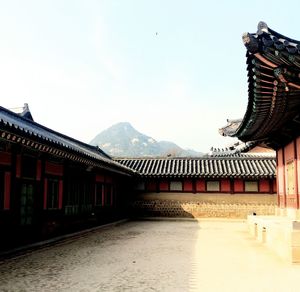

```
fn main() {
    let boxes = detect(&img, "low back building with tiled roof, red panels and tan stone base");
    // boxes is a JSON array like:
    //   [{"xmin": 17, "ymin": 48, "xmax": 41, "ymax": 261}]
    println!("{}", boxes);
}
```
[{"xmin": 117, "ymin": 152, "xmax": 276, "ymax": 218}]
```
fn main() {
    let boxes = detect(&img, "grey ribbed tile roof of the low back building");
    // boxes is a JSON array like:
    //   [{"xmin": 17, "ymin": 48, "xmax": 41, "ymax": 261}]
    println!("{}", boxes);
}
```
[{"xmin": 117, "ymin": 156, "xmax": 276, "ymax": 178}]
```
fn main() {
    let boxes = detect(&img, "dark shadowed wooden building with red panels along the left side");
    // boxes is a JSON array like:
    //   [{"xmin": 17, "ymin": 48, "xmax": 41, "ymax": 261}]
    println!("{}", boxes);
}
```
[{"xmin": 0, "ymin": 106, "xmax": 134, "ymax": 248}]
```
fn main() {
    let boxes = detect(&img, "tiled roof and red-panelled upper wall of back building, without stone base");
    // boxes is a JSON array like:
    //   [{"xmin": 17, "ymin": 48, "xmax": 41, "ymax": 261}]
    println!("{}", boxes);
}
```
[{"xmin": 117, "ymin": 153, "xmax": 276, "ymax": 194}]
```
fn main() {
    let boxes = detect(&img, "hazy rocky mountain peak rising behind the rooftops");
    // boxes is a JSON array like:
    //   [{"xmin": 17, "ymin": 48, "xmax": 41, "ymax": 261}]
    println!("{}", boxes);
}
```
[{"xmin": 90, "ymin": 122, "xmax": 202, "ymax": 157}]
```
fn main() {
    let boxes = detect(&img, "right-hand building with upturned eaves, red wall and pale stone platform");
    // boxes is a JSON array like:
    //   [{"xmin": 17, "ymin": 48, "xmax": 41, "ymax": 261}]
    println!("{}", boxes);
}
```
[{"xmin": 220, "ymin": 22, "xmax": 300, "ymax": 262}]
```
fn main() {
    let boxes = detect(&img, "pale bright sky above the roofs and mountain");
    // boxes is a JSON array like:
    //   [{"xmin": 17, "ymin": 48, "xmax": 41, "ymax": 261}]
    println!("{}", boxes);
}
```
[{"xmin": 0, "ymin": 0, "xmax": 300, "ymax": 152}]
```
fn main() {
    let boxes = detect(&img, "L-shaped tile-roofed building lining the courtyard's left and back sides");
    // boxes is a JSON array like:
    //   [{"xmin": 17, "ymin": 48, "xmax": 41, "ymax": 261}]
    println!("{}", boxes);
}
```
[{"xmin": 0, "ymin": 101, "xmax": 276, "ymax": 248}]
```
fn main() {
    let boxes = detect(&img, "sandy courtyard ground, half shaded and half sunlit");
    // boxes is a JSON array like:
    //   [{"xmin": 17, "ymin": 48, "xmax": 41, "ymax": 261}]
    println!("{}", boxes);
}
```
[{"xmin": 0, "ymin": 220, "xmax": 300, "ymax": 292}]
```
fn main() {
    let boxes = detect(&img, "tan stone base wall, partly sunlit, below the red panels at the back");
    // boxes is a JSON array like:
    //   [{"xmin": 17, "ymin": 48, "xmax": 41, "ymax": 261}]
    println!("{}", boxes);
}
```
[{"xmin": 131, "ymin": 193, "xmax": 276, "ymax": 219}]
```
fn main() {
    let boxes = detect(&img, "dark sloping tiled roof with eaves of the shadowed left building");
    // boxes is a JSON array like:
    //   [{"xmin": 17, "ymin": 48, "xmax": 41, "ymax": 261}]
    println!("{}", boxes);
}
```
[{"xmin": 0, "ymin": 107, "xmax": 132, "ymax": 173}]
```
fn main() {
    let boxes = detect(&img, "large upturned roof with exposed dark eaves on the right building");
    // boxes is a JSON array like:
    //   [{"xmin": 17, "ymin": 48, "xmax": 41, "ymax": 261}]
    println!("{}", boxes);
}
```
[{"xmin": 220, "ymin": 22, "xmax": 300, "ymax": 149}]
